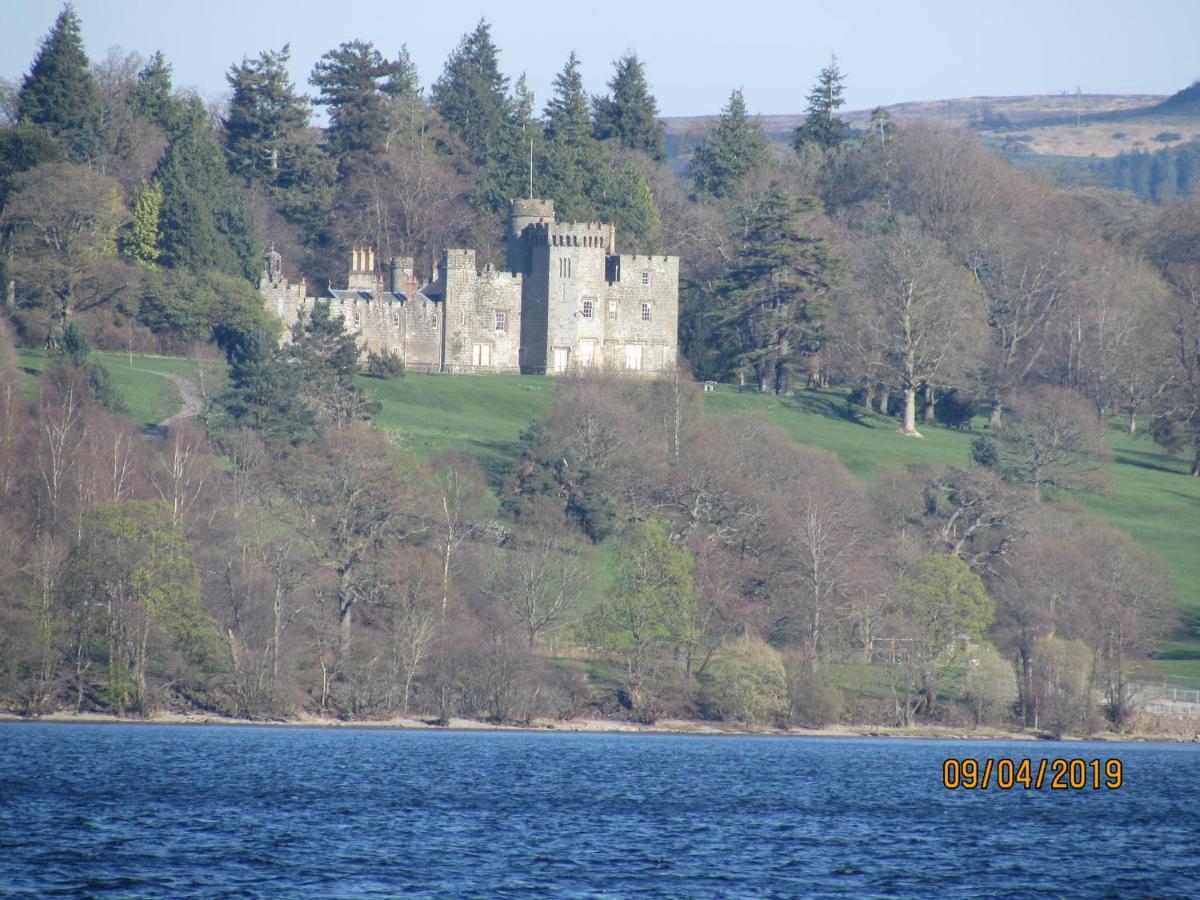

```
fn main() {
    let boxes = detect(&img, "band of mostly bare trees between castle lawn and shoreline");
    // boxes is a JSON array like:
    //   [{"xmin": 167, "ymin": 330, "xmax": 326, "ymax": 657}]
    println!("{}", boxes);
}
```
[{"xmin": 0, "ymin": 316, "xmax": 1174, "ymax": 731}]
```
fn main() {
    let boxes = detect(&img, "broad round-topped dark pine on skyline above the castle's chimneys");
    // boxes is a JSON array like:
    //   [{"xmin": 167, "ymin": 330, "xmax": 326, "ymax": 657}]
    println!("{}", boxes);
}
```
[{"xmin": 308, "ymin": 41, "xmax": 400, "ymax": 157}]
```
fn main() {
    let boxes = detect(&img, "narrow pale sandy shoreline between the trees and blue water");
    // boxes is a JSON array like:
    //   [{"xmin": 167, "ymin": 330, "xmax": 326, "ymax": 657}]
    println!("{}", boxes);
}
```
[{"xmin": 0, "ymin": 712, "xmax": 1200, "ymax": 744}]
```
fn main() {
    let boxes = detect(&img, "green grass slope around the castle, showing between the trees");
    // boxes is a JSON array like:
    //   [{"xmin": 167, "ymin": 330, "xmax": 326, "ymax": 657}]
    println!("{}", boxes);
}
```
[{"xmin": 20, "ymin": 350, "xmax": 1200, "ymax": 683}]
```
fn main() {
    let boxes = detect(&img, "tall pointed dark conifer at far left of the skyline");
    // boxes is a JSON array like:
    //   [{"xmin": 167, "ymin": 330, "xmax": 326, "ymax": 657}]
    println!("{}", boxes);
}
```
[{"xmin": 17, "ymin": 4, "xmax": 102, "ymax": 162}]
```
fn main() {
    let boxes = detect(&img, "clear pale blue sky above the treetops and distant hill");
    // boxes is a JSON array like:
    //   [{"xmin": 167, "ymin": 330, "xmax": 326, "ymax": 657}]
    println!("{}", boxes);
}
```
[{"xmin": 0, "ymin": 0, "xmax": 1200, "ymax": 115}]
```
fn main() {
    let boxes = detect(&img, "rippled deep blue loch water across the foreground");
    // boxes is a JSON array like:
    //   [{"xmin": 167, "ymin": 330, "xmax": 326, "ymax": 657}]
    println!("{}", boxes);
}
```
[{"xmin": 0, "ymin": 724, "xmax": 1200, "ymax": 898}]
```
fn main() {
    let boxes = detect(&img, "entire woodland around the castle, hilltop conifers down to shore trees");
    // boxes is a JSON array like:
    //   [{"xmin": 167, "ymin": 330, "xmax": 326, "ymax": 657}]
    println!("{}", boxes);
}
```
[{"xmin": 0, "ymin": 7, "xmax": 1200, "ymax": 730}]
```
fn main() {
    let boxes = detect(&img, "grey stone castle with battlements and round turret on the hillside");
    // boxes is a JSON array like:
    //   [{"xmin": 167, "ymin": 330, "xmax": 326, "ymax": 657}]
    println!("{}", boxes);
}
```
[{"xmin": 259, "ymin": 199, "xmax": 679, "ymax": 374}]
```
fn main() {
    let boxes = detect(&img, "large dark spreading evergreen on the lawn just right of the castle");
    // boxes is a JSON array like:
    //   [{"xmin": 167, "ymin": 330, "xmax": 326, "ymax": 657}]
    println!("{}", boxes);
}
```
[{"xmin": 715, "ymin": 191, "xmax": 838, "ymax": 394}]
